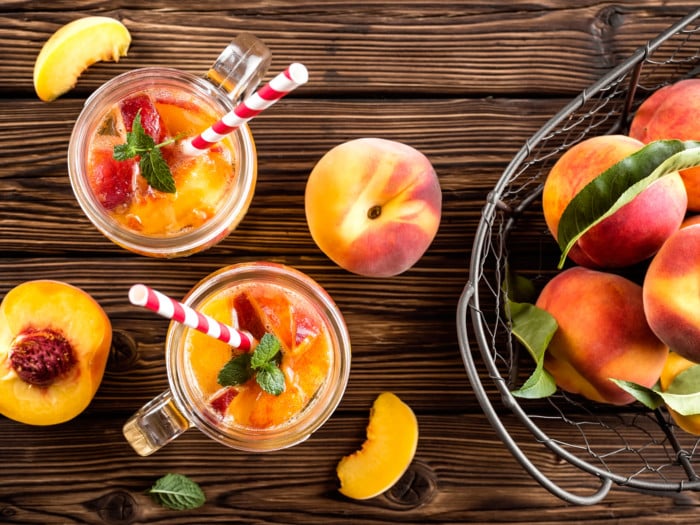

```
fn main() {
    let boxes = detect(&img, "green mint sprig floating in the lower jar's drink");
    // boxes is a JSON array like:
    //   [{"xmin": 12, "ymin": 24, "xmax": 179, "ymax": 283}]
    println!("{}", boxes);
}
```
[{"xmin": 217, "ymin": 333, "xmax": 285, "ymax": 396}]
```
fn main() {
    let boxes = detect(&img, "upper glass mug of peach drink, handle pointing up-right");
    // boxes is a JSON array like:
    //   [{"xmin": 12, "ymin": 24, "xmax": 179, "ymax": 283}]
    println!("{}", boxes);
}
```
[{"xmin": 68, "ymin": 34, "xmax": 270, "ymax": 257}]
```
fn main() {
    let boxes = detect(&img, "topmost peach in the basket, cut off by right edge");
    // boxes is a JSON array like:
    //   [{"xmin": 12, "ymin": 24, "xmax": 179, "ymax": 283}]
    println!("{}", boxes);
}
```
[{"xmin": 629, "ymin": 78, "xmax": 700, "ymax": 211}]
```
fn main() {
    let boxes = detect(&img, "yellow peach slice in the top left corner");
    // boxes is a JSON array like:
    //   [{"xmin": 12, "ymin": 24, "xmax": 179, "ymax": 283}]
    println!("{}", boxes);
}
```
[{"xmin": 34, "ymin": 16, "xmax": 131, "ymax": 102}]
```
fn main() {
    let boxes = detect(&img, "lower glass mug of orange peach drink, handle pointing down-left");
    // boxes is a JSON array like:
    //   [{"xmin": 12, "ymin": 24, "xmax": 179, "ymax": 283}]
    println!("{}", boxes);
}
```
[{"xmin": 124, "ymin": 262, "xmax": 351, "ymax": 455}]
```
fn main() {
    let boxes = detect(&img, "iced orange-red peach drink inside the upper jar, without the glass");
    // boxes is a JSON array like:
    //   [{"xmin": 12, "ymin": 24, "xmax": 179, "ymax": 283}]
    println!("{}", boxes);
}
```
[{"xmin": 87, "ymin": 87, "xmax": 236, "ymax": 237}]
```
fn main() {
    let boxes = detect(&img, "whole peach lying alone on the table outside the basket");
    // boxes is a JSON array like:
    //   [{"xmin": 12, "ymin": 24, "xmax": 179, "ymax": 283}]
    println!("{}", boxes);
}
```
[{"xmin": 305, "ymin": 138, "xmax": 442, "ymax": 277}]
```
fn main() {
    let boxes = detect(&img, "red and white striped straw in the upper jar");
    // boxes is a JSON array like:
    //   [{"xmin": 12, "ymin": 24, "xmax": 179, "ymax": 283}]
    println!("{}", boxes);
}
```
[{"xmin": 183, "ymin": 62, "xmax": 309, "ymax": 155}]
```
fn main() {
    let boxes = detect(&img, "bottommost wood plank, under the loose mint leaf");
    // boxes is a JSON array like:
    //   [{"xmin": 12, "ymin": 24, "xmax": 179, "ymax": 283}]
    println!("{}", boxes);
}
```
[{"xmin": 0, "ymin": 413, "xmax": 699, "ymax": 524}]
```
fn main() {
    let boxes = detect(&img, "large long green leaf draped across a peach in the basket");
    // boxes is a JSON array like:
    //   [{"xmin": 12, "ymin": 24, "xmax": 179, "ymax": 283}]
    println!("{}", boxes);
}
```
[{"xmin": 557, "ymin": 140, "xmax": 700, "ymax": 268}]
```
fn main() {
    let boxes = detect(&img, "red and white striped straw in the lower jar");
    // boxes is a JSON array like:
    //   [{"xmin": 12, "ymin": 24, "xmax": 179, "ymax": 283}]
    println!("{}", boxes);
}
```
[{"xmin": 129, "ymin": 284, "xmax": 253, "ymax": 352}]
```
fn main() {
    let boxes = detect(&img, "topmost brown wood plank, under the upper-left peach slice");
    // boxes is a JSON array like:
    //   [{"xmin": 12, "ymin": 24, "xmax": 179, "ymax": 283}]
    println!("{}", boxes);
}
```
[{"xmin": 0, "ymin": 0, "xmax": 697, "ymax": 96}]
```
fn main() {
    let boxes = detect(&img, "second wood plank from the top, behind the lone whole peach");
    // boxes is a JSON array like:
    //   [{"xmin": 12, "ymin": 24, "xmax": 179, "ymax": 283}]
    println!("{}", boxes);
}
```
[{"xmin": 0, "ymin": 99, "xmax": 563, "ymax": 257}]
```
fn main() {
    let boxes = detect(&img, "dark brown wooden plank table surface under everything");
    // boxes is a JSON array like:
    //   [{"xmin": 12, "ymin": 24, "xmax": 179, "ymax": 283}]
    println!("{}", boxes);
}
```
[{"xmin": 0, "ymin": 0, "xmax": 700, "ymax": 524}]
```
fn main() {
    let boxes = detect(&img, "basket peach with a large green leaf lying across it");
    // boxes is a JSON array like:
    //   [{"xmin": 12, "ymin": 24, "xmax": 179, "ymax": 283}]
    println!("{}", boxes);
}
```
[{"xmin": 542, "ymin": 135, "xmax": 687, "ymax": 268}]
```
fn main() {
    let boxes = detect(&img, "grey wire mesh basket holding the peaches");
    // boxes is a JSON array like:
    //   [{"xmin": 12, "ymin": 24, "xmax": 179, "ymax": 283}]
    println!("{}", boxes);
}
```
[{"xmin": 457, "ymin": 9, "xmax": 700, "ymax": 505}]
